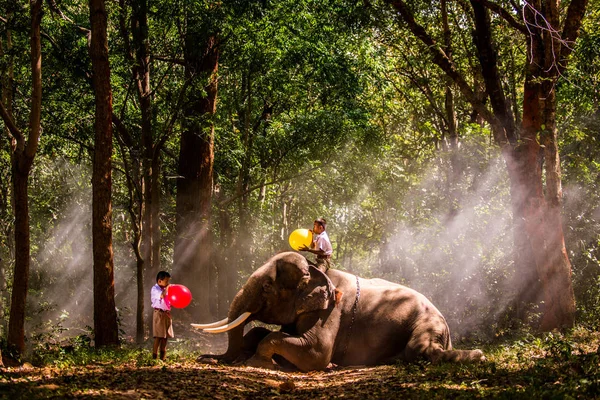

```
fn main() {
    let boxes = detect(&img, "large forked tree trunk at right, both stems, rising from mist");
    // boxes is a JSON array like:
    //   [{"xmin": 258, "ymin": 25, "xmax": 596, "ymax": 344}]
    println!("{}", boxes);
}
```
[{"xmin": 471, "ymin": 0, "xmax": 575, "ymax": 331}]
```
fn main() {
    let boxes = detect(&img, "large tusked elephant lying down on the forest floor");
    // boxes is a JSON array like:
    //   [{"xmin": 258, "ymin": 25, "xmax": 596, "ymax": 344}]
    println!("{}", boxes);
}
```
[{"xmin": 192, "ymin": 252, "xmax": 485, "ymax": 371}]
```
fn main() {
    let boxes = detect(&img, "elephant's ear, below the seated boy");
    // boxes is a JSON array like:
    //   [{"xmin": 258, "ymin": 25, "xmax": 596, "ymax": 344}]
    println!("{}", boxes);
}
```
[{"xmin": 296, "ymin": 266, "xmax": 342, "ymax": 314}]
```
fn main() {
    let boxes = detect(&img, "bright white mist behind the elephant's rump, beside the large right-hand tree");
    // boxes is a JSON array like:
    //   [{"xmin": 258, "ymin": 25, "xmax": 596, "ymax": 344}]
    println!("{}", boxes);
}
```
[{"xmin": 380, "ymin": 159, "xmax": 514, "ymax": 340}]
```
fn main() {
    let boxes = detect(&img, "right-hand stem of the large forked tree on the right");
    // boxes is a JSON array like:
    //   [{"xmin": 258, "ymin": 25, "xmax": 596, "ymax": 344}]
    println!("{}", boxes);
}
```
[{"xmin": 522, "ymin": 0, "xmax": 586, "ymax": 331}]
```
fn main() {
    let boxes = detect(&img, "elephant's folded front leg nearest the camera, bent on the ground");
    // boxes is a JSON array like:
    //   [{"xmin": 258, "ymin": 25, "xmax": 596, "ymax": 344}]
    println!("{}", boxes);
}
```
[{"xmin": 246, "ymin": 332, "xmax": 331, "ymax": 371}]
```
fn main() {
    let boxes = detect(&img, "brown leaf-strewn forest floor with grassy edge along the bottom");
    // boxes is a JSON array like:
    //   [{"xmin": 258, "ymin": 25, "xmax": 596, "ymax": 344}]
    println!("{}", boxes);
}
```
[{"xmin": 0, "ymin": 326, "xmax": 600, "ymax": 399}]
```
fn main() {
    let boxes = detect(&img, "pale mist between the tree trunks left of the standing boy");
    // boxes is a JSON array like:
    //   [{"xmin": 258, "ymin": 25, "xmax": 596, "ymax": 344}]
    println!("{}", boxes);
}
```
[{"xmin": 26, "ymin": 165, "xmax": 137, "ymax": 344}]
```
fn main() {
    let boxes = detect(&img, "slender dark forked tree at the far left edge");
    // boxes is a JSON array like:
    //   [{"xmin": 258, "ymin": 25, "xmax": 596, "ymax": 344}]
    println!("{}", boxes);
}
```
[{"xmin": 0, "ymin": 0, "xmax": 43, "ymax": 353}]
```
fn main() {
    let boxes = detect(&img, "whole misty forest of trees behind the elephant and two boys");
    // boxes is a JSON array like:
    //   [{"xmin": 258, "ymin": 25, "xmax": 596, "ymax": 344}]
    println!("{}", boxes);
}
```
[{"xmin": 0, "ymin": 0, "xmax": 600, "ymax": 366}]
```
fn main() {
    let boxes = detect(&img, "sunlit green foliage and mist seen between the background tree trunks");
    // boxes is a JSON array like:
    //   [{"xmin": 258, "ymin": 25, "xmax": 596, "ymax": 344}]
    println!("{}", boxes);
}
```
[{"xmin": 0, "ymin": 0, "xmax": 600, "ymax": 354}]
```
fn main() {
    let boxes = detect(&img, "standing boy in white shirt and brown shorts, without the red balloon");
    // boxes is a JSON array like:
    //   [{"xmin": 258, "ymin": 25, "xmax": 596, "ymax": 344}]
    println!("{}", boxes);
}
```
[{"xmin": 150, "ymin": 271, "xmax": 173, "ymax": 360}]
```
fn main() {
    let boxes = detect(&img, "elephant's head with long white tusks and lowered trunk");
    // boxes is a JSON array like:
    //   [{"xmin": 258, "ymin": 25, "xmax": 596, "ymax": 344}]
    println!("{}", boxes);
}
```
[{"xmin": 192, "ymin": 252, "xmax": 340, "ymax": 362}]
